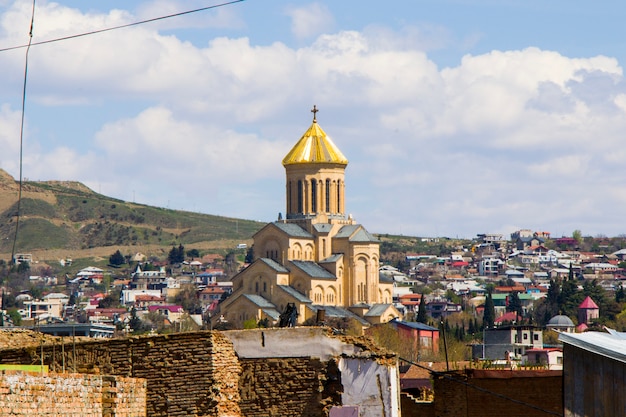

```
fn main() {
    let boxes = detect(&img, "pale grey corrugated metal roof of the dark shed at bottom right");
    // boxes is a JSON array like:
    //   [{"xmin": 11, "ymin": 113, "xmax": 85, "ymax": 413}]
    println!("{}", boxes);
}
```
[{"xmin": 559, "ymin": 330, "xmax": 626, "ymax": 363}]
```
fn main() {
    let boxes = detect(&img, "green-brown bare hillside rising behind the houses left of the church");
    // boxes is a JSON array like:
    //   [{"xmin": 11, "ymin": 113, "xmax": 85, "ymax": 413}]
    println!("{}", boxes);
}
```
[{"xmin": 0, "ymin": 169, "xmax": 263, "ymax": 259}]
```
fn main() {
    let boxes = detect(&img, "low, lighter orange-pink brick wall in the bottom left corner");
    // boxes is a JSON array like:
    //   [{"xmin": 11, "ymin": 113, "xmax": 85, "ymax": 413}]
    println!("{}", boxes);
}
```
[{"xmin": 0, "ymin": 371, "xmax": 146, "ymax": 417}]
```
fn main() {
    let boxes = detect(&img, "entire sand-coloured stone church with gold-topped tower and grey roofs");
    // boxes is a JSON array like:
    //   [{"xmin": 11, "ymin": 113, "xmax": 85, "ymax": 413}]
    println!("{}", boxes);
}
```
[{"xmin": 218, "ymin": 106, "xmax": 401, "ymax": 328}]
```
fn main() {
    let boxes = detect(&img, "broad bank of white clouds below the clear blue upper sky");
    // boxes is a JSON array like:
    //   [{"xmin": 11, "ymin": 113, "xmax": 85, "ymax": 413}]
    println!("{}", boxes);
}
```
[{"xmin": 0, "ymin": 2, "xmax": 626, "ymax": 236}]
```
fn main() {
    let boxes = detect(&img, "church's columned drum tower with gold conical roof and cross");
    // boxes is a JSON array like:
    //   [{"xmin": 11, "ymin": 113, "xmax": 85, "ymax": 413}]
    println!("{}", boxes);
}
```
[{"xmin": 283, "ymin": 106, "xmax": 348, "ymax": 220}]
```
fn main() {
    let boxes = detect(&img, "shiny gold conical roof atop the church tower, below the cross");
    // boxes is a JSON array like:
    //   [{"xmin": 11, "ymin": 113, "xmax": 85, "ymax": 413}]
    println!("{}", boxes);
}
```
[{"xmin": 283, "ymin": 119, "xmax": 348, "ymax": 166}]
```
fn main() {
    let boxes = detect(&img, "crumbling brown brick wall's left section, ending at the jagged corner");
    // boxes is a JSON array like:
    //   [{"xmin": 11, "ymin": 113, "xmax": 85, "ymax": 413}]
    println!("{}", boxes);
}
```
[{"xmin": 0, "ymin": 332, "xmax": 241, "ymax": 417}]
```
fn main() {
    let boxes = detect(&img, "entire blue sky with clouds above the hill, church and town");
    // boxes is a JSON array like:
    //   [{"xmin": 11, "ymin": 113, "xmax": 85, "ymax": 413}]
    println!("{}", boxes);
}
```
[{"xmin": 0, "ymin": 0, "xmax": 626, "ymax": 237}]
